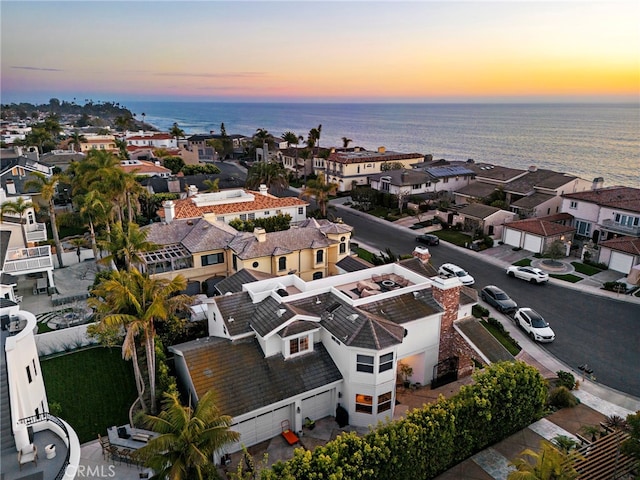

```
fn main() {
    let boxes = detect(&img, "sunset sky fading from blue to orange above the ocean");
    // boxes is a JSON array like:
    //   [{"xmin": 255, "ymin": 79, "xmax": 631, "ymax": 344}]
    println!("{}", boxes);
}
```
[{"xmin": 0, "ymin": 0, "xmax": 640, "ymax": 104}]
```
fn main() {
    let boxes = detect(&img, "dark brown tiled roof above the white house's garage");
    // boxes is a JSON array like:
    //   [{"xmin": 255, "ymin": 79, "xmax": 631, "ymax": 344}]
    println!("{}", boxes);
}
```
[{"xmin": 171, "ymin": 337, "xmax": 342, "ymax": 417}]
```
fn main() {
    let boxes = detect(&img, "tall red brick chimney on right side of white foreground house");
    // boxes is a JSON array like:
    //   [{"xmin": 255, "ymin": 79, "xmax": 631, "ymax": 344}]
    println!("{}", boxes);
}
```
[{"xmin": 431, "ymin": 277, "xmax": 462, "ymax": 361}]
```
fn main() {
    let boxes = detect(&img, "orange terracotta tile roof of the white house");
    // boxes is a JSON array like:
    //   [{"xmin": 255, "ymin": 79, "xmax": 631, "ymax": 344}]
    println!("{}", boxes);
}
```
[{"xmin": 166, "ymin": 190, "xmax": 309, "ymax": 218}]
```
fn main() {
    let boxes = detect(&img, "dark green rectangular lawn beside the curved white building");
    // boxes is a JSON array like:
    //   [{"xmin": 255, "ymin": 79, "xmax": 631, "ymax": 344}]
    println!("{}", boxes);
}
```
[{"xmin": 40, "ymin": 347, "xmax": 136, "ymax": 443}]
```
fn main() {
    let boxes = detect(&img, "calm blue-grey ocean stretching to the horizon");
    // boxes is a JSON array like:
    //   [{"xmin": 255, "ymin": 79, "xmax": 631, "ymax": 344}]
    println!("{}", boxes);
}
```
[{"xmin": 126, "ymin": 102, "xmax": 640, "ymax": 188}]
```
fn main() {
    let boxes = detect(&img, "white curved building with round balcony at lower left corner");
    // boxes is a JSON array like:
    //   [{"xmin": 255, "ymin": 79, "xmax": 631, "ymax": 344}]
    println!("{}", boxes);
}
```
[{"xmin": 0, "ymin": 298, "xmax": 80, "ymax": 480}]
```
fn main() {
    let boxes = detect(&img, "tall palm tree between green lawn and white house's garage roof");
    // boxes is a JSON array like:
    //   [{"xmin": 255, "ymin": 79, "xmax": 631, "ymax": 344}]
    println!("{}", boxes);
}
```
[{"xmin": 88, "ymin": 268, "xmax": 191, "ymax": 412}]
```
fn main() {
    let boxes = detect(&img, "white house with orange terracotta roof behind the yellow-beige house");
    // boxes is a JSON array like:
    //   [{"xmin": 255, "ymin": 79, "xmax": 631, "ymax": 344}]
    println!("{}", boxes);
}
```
[{"xmin": 158, "ymin": 185, "xmax": 309, "ymax": 227}]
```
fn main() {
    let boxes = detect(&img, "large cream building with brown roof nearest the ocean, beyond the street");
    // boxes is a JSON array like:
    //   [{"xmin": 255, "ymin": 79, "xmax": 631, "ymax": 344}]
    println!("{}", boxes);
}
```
[{"xmin": 324, "ymin": 147, "xmax": 424, "ymax": 192}]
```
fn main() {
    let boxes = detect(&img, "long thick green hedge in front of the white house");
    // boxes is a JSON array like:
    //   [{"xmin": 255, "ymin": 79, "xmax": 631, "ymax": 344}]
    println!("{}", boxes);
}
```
[{"xmin": 261, "ymin": 362, "xmax": 547, "ymax": 480}]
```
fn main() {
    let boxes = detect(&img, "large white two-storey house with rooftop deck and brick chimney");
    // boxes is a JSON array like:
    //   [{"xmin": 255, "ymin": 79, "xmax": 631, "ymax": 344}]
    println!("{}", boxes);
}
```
[{"xmin": 170, "ymin": 264, "xmax": 480, "ymax": 452}]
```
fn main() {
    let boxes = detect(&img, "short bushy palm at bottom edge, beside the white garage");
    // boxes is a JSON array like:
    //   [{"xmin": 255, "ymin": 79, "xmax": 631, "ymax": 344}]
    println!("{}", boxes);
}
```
[{"xmin": 136, "ymin": 390, "xmax": 240, "ymax": 480}]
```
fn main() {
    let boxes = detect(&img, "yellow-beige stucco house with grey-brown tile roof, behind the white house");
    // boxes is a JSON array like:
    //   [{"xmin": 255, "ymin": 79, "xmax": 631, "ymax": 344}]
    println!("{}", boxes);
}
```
[{"xmin": 143, "ymin": 218, "xmax": 353, "ymax": 284}]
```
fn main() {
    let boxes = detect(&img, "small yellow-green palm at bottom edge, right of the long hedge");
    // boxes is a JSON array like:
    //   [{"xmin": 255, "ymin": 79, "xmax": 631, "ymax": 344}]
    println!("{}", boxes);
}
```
[{"xmin": 507, "ymin": 440, "xmax": 580, "ymax": 480}]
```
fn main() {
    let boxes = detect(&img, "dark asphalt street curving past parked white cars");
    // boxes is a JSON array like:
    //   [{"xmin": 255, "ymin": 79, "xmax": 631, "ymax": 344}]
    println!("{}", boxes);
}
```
[{"xmin": 332, "ymin": 202, "xmax": 640, "ymax": 397}]
